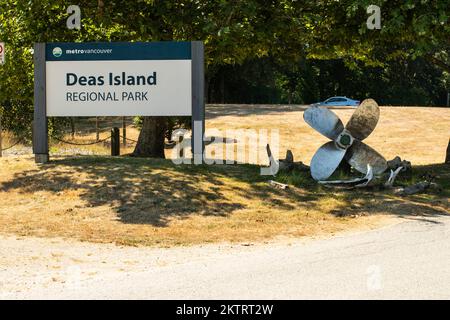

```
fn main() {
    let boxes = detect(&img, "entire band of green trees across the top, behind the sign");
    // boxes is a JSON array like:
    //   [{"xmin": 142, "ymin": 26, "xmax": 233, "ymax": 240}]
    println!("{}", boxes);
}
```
[{"xmin": 0, "ymin": 0, "xmax": 450, "ymax": 139}]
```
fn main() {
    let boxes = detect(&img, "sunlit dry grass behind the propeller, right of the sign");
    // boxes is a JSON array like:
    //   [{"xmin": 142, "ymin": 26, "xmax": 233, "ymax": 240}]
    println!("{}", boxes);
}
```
[{"xmin": 206, "ymin": 106, "xmax": 450, "ymax": 165}]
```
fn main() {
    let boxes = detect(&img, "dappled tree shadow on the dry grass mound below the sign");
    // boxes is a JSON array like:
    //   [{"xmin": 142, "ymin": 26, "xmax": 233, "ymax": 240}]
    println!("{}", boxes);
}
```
[{"xmin": 0, "ymin": 156, "xmax": 320, "ymax": 227}]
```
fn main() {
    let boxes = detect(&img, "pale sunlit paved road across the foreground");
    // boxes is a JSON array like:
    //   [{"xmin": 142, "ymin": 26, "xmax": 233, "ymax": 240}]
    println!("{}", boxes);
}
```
[{"xmin": 0, "ymin": 216, "xmax": 450, "ymax": 299}]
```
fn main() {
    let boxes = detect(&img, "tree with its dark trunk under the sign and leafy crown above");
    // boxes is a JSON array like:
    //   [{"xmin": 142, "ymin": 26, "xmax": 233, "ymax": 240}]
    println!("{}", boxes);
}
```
[{"xmin": 128, "ymin": 0, "xmax": 314, "ymax": 157}]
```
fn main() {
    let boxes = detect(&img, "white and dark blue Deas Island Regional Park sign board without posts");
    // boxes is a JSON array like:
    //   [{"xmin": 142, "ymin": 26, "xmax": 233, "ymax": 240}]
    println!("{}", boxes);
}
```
[{"xmin": 45, "ymin": 42, "xmax": 192, "ymax": 117}]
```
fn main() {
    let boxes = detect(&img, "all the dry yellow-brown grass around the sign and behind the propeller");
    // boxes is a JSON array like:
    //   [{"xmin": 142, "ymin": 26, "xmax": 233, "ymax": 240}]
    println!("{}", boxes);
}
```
[{"xmin": 0, "ymin": 106, "xmax": 450, "ymax": 246}]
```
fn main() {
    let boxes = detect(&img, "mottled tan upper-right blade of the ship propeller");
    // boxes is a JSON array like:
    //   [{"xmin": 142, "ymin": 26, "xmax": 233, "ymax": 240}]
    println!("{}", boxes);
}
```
[{"xmin": 345, "ymin": 99, "xmax": 380, "ymax": 141}]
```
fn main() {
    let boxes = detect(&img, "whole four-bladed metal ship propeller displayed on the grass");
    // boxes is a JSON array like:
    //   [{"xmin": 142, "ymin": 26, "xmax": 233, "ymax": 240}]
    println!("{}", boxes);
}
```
[{"xmin": 303, "ymin": 99, "xmax": 387, "ymax": 181}]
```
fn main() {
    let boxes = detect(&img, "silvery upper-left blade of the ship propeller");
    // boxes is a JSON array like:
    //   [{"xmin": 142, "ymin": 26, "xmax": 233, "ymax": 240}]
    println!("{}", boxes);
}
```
[{"xmin": 303, "ymin": 106, "xmax": 344, "ymax": 140}]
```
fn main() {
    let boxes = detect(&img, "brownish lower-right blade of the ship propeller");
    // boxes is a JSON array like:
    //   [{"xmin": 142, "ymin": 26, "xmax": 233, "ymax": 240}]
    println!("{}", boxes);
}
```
[{"xmin": 345, "ymin": 140, "xmax": 387, "ymax": 175}]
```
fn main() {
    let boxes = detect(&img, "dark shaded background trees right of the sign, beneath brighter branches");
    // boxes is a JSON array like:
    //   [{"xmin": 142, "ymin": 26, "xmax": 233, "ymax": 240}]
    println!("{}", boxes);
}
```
[{"xmin": 208, "ymin": 58, "xmax": 448, "ymax": 106}]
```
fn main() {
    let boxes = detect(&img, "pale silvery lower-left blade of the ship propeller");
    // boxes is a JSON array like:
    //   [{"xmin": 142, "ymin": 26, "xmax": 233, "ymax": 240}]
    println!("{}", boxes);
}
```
[{"xmin": 310, "ymin": 141, "xmax": 346, "ymax": 181}]
